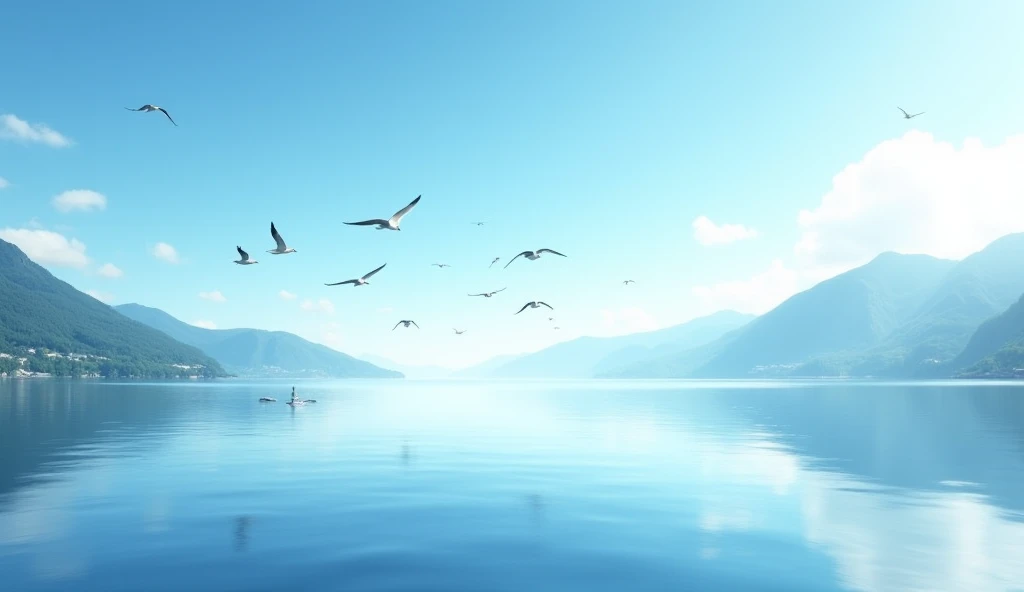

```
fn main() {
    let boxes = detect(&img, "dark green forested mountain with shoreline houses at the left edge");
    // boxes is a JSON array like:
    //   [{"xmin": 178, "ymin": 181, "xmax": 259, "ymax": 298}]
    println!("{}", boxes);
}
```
[{"xmin": 0, "ymin": 241, "xmax": 225, "ymax": 378}]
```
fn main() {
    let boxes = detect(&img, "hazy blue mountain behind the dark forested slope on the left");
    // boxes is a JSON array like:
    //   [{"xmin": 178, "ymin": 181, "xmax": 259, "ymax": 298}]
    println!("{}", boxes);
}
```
[{"xmin": 115, "ymin": 304, "xmax": 402, "ymax": 378}]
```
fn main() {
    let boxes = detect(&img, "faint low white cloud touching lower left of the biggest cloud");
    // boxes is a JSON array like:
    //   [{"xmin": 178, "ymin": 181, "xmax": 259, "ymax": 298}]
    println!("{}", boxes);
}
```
[{"xmin": 692, "ymin": 259, "xmax": 803, "ymax": 314}]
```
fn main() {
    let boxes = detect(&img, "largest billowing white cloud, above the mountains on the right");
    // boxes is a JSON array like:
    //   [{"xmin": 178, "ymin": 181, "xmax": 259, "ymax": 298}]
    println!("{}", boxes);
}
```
[{"xmin": 795, "ymin": 131, "xmax": 1024, "ymax": 269}]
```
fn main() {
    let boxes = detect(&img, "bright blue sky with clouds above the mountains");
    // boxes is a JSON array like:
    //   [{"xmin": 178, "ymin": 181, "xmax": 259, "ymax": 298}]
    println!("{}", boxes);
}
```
[{"xmin": 0, "ymin": 1, "xmax": 1024, "ymax": 367}]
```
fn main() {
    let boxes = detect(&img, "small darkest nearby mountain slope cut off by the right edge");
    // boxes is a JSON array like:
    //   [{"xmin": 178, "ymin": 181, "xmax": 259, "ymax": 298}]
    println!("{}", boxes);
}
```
[{"xmin": 951, "ymin": 296, "xmax": 1024, "ymax": 377}]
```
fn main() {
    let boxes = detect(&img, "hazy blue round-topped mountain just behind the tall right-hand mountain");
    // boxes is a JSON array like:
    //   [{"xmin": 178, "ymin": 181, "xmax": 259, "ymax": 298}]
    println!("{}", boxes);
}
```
[{"xmin": 692, "ymin": 253, "xmax": 956, "ymax": 378}]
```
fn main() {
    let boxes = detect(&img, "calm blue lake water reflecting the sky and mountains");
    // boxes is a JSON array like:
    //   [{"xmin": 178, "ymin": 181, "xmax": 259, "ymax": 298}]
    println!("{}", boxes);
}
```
[{"xmin": 0, "ymin": 380, "xmax": 1024, "ymax": 592}]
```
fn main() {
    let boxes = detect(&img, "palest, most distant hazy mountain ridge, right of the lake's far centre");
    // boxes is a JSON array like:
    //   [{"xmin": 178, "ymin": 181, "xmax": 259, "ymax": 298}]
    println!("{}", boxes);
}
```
[{"xmin": 468, "ymin": 310, "xmax": 753, "ymax": 378}]
